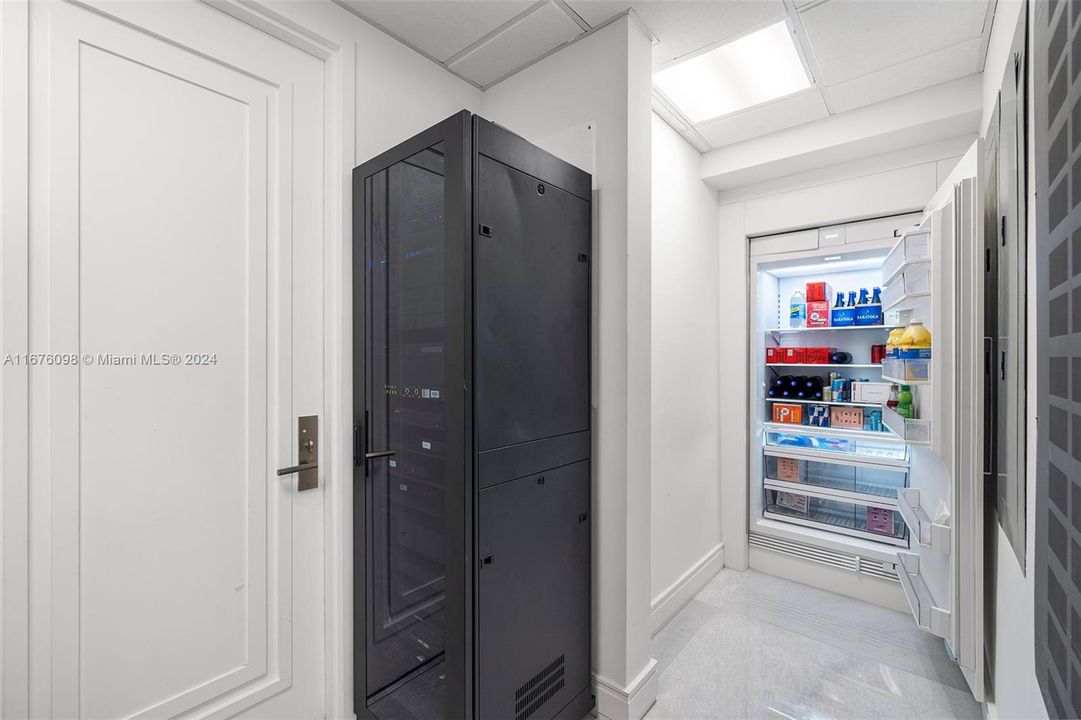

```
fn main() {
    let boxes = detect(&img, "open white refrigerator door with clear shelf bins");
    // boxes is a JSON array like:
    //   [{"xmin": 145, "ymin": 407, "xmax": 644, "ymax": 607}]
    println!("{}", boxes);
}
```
[{"xmin": 897, "ymin": 178, "xmax": 984, "ymax": 701}]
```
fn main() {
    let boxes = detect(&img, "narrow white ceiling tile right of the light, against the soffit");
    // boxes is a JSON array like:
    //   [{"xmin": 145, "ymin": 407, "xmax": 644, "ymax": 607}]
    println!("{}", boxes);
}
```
[{"xmin": 827, "ymin": 38, "xmax": 980, "ymax": 112}]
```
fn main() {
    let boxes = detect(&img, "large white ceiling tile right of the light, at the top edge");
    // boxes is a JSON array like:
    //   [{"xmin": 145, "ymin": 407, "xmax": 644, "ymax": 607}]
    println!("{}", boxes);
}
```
[{"xmin": 800, "ymin": 0, "xmax": 988, "ymax": 85}]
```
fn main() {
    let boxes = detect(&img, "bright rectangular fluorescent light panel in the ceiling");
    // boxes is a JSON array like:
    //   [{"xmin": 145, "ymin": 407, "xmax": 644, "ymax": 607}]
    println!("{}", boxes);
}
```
[{"xmin": 653, "ymin": 22, "xmax": 811, "ymax": 123}]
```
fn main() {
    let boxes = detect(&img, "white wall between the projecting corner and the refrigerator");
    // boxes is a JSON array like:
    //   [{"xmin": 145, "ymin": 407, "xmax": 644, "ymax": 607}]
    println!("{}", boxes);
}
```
[{"xmin": 650, "ymin": 115, "xmax": 726, "ymax": 626}]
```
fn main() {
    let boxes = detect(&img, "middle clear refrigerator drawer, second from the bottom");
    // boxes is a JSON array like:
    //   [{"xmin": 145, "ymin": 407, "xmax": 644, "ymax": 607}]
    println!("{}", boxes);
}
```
[{"xmin": 765, "ymin": 454, "xmax": 908, "ymax": 503}]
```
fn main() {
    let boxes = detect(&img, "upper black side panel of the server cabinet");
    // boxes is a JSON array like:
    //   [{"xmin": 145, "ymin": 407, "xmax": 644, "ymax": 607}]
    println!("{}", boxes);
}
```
[{"xmin": 473, "ymin": 156, "xmax": 589, "ymax": 452}]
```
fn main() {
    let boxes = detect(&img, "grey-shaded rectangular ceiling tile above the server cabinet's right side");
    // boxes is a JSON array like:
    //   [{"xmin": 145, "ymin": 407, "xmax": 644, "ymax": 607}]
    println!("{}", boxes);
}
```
[{"xmin": 450, "ymin": 3, "xmax": 583, "ymax": 88}]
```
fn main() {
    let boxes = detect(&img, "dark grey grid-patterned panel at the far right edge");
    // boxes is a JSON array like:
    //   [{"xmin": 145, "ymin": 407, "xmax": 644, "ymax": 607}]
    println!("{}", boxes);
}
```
[{"xmin": 1033, "ymin": 2, "xmax": 1081, "ymax": 718}]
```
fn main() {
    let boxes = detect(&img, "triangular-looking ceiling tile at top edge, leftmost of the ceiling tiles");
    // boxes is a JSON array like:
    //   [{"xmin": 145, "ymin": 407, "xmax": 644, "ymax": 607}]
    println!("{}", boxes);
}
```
[{"xmin": 341, "ymin": 0, "xmax": 535, "ymax": 61}]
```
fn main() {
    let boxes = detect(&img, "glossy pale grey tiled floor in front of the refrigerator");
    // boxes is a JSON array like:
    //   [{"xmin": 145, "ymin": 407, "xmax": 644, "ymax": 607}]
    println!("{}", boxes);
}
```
[{"xmin": 646, "ymin": 569, "xmax": 982, "ymax": 720}]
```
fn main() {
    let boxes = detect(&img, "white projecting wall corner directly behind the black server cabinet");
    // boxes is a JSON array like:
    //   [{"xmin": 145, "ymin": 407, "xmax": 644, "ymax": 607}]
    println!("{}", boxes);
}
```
[{"xmin": 482, "ymin": 16, "xmax": 656, "ymax": 720}]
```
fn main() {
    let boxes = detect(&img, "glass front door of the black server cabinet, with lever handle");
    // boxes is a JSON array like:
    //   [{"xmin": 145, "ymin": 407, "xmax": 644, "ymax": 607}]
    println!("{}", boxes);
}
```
[{"xmin": 352, "ymin": 112, "xmax": 473, "ymax": 718}]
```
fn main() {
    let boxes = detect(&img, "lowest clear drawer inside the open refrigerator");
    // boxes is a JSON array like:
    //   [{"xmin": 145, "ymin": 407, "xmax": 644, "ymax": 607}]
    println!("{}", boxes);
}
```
[{"xmin": 763, "ymin": 485, "xmax": 908, "ymax": 547}]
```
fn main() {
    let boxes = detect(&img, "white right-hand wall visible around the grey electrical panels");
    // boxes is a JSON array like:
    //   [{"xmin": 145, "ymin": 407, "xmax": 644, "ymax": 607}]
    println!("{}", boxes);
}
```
[{"xmin": 980, "ymin": 0, "xmax": 1047, "ymax": 720}]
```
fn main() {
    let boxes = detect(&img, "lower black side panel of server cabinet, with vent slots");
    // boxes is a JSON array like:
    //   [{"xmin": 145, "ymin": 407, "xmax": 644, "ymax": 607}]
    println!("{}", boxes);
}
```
[{"xmin": 477, "ymin": 461, "xmax": 590, "ymax": 720}]
